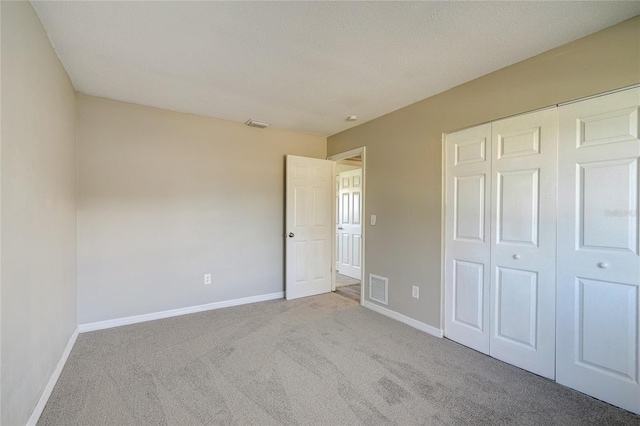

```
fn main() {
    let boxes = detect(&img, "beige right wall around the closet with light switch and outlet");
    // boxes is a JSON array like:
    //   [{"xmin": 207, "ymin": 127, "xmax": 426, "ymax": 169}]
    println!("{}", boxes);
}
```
[{"xmin": 327, "ymin": 17, "xmax": 640, "ymax": 328}]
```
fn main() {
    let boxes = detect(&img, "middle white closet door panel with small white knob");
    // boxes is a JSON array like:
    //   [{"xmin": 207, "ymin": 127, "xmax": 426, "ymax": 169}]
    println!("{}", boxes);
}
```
[{"xmin": 490, "ymin": 108, "xmax": 558, "ymax": 379}]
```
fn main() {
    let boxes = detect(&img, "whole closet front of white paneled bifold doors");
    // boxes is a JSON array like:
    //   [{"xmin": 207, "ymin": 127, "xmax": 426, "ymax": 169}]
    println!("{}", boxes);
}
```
[{"xmin": 444, "ymin": 88, "xmax": 640, "ymax": 413}]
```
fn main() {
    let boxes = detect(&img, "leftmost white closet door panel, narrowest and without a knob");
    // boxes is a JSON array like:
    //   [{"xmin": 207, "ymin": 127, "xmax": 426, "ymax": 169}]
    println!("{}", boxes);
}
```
[{"xmin": 445, "ymin": 124, "xmax": 491, "ymax": 353}]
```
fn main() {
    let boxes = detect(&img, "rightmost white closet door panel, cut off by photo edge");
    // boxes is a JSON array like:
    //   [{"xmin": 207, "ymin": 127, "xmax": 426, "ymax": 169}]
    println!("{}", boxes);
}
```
[{"xmin": 557, "ymin": 89, "xmax": 640, "ymax": 413}]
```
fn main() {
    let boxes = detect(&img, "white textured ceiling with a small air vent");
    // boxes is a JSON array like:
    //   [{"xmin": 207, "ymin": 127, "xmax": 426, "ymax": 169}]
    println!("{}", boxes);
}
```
[{"xmin": 32, "ymin": 1, "xmax": 640, "ymax": 136}]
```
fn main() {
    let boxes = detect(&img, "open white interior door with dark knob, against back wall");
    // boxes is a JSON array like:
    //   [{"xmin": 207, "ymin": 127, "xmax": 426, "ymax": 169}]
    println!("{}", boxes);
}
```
[{"xmin": 285, "ymin": 155, "xmax": 335, "ymax": 300}]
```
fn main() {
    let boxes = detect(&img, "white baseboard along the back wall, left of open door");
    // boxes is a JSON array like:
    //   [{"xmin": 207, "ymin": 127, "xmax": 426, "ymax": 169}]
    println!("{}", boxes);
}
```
[{"xmin": 78, "ymin": 291, "xmax": 284, "ymax": 333}]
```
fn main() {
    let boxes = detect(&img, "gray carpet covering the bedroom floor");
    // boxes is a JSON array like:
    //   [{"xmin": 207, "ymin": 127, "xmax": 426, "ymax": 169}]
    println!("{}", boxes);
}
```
[{"xmin": 39, "ymin": 293, "xmax": 640, "ymax": 425}]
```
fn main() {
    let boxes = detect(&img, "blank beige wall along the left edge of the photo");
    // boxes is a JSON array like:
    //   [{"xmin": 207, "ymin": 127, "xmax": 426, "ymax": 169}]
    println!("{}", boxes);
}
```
[{"xmin": 0, "ymin": 2, "xmax": 77, "ymax": 425}]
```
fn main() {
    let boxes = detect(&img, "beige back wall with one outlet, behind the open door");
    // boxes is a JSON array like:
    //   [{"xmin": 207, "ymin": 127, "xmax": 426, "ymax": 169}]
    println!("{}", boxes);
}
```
[{"xmin": 77, "ymin": 95, "xmax": 326, "ymax": 324}]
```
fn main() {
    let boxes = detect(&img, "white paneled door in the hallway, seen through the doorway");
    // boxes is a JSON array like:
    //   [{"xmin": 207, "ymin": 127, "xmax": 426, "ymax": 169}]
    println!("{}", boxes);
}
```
[{"xmin": 336, "ymin": 169, "xmax": 362, "ymax": 280}]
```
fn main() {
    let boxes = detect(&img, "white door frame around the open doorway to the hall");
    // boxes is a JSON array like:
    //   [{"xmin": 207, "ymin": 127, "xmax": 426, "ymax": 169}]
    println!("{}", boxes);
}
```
[{"xmin": 327, "ymin": 146, "xmax": 367, "ymax": 305}]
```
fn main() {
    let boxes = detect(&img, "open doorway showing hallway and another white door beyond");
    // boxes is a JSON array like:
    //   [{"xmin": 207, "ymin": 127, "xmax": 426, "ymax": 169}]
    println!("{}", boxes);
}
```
[{"xmin": 328, "ymin": 147, "xmax": 365, "ymax": 304}]
